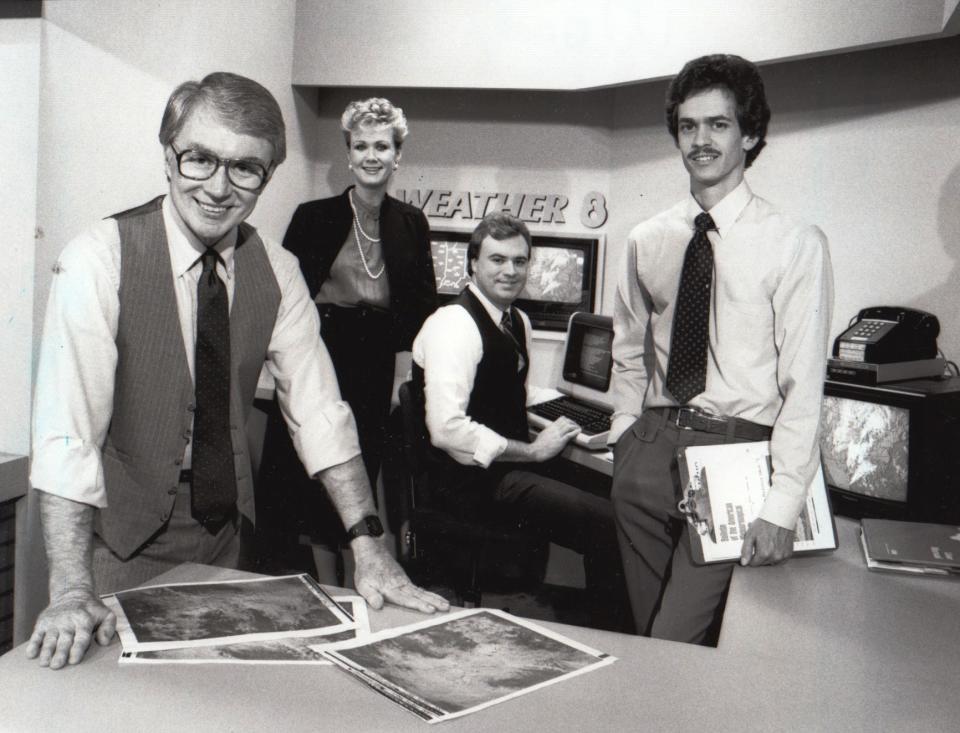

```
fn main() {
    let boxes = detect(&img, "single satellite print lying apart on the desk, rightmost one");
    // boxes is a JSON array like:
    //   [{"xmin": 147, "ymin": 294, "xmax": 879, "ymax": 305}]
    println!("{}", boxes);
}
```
[{"xmin": 316, "ymin": 608, "xmax": 616, "ymax": 723}]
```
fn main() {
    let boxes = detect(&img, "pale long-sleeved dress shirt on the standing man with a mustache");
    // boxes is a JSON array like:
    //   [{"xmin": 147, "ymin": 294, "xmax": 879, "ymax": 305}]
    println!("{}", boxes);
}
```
[{"xmin": 610, "ymin": 181, "xmax": 833, "ymax": 529}]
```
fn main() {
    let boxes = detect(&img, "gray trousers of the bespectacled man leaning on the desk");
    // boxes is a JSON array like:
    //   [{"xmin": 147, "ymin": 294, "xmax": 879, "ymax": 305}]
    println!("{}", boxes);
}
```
[{"xmin": 93, "ymin": 483, "xmax": 249, "ymax": 595}]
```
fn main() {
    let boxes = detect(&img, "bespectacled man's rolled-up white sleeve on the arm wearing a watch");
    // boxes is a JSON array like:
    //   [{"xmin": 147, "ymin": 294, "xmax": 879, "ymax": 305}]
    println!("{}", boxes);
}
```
[{"xmin": 266, "ymin": 247, "xmax": 360, "ymax": 476}]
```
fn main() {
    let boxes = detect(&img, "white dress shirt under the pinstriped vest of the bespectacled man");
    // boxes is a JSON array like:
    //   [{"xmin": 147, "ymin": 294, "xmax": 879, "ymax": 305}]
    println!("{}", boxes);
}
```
[{"xmin": 30, "ymin": 197, "xmax": 360, "ymax": 507}]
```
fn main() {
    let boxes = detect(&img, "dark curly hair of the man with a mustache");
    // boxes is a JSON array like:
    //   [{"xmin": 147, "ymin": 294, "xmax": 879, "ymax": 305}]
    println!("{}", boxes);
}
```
[{"xmin": 666, "ymin": 53, "xmax": 770, "ymax": 168}]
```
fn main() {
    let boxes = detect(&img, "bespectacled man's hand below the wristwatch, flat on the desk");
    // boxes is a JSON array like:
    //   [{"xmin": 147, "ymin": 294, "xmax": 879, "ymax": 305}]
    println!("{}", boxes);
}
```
[{"xmin": 350, "ymin": 537, "xmax": 450, "ymax": 613}]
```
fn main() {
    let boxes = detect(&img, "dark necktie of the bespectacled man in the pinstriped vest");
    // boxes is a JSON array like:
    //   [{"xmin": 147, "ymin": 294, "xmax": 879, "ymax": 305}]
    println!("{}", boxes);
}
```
[{"xmin": 191, "ymin": 248, "xmax": 237, "ymax": 525}]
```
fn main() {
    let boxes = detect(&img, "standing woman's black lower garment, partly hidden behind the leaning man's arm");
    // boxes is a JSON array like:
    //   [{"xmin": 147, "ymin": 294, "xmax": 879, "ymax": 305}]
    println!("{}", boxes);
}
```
[{"xmin": 257, "ymin": 305, "xmax": 395, "ymax": 571}]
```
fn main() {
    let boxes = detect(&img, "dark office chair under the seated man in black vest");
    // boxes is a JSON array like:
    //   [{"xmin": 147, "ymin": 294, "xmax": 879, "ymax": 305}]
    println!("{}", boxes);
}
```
[{"xmin": 391, "ymin": 382, "xmax": 547, "ymax": 606}]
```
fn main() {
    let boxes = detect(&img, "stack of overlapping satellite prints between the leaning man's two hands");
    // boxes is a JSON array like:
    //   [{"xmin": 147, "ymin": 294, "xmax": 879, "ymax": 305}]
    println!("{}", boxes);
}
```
[{"xmin": 104, "ymin": 574, "xmax": 370, "ymax": 664}]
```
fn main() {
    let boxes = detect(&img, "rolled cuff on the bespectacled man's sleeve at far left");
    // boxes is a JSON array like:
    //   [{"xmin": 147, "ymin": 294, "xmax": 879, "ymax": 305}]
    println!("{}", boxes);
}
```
[{"xmin": 30, "ymin": 436, "xmax": 107, "ymax": 509}]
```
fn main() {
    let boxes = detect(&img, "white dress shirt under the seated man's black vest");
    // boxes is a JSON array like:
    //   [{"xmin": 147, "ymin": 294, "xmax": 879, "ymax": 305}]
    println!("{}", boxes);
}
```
[{"xmin": 413, "ymin": 282, "xmax": 554, "ymax": 468}]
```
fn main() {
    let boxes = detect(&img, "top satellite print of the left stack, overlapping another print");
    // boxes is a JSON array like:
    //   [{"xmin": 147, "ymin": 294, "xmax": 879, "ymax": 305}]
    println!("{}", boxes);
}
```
[{"xmin": 103, "ymin": 574, "xmax": 353, "ymax": 652}]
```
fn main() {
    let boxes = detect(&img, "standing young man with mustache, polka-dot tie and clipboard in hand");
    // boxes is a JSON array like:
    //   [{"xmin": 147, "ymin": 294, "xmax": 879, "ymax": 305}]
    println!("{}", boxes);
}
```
[{"xmin": 610, "ymin": 55, "xmax": 833, "ymax": 643}]
